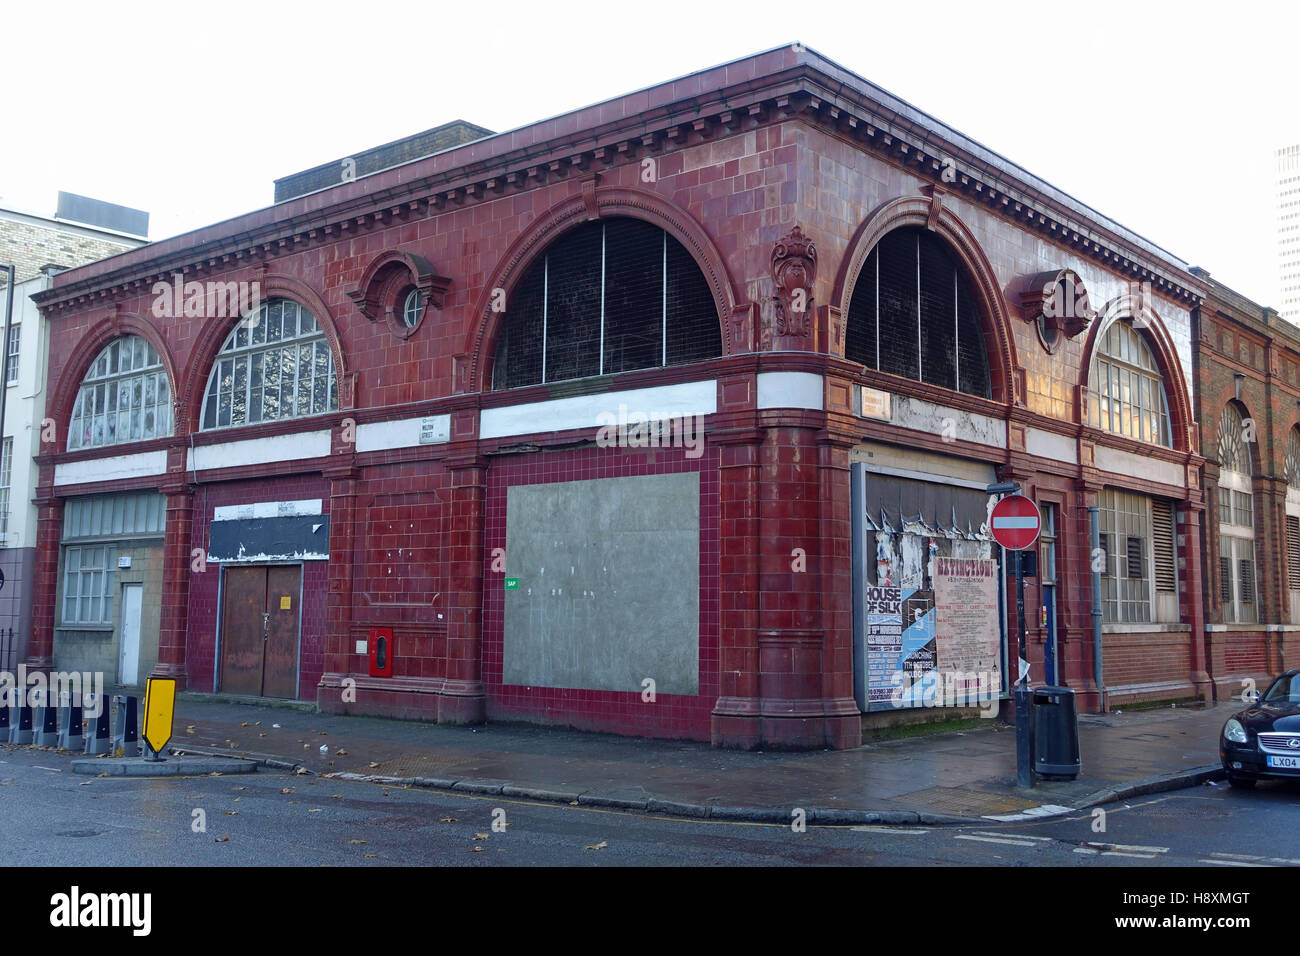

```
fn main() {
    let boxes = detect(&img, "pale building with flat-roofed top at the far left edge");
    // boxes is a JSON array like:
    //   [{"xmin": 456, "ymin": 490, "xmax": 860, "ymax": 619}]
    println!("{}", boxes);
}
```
[{"xmin": 0, "ymin": 193, "xmax": 148, "ymax": 671}]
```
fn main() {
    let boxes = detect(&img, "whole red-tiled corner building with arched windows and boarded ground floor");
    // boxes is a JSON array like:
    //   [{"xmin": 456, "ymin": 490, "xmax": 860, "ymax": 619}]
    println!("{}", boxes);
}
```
[{"xmin": 33, "ymin": 47, "xmax": 1210, "ymax": 747}]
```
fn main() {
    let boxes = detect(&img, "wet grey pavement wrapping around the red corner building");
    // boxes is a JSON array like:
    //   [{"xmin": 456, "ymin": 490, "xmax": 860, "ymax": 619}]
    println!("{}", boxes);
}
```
[{"xmin": 71, "ymin": 693, "xmax": 1242, "ymax": 825}]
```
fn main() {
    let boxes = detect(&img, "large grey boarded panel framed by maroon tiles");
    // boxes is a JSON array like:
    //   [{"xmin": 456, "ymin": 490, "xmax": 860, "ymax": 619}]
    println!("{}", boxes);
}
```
[{"xmin": 491, "ymin": 472, "xmax": 699, "ymax": 695}]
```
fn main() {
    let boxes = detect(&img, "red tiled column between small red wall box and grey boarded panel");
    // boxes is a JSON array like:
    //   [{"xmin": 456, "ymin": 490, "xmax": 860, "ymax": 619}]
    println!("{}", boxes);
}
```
[{"xmin": 438, "ymin": 458, "xmax": 488, "ymax": 723}]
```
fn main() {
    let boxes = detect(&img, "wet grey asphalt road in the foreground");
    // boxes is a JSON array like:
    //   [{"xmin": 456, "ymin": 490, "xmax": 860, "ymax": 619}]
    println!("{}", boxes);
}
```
[{"xmin": 0, "ymin": 748, "xmax": 1300, "ymax": 869}]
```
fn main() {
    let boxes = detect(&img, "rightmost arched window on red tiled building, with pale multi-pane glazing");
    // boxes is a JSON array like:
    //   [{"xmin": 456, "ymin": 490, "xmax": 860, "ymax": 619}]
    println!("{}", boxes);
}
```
[{"xmin": 1088, "ymin": 319, "xmax": 1173, "ymax": 447}]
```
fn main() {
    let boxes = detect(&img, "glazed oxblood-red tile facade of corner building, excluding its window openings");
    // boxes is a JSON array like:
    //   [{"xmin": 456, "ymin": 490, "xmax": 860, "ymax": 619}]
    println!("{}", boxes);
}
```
[{"xmin": 33, "ymin": 48, "xmax": 1248, "ymax": 747}]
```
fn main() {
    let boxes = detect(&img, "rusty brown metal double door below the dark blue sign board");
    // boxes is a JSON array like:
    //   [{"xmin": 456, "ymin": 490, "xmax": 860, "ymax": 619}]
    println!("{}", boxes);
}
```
[{"xmin": 221, "ymin": 566, "xmax": 303, "ymax": 697}]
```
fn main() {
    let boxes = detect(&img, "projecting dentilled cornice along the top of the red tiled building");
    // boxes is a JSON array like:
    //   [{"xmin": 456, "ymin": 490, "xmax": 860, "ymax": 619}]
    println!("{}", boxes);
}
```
[{"xmin": 34, "ymin": 48, "xmax": 1206, "ymax": 316}]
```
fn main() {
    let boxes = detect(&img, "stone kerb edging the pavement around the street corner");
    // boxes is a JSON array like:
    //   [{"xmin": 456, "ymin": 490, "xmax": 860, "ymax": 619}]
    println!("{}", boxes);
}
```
[{"xmin": 159, "ymin": 748, "xmax": 1226, "ymax": 826}]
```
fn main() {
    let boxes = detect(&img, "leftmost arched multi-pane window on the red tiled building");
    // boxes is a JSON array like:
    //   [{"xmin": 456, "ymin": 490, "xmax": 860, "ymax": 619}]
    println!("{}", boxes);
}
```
[{"xmin": 68, "ymin": 336, "xmax": 172, "ymax": 451}]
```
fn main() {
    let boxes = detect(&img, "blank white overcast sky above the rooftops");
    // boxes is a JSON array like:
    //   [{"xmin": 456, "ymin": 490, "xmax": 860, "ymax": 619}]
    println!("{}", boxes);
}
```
[{"xmin": 0, "ymin": 0, "xmax": 1300, "ymax": 304}]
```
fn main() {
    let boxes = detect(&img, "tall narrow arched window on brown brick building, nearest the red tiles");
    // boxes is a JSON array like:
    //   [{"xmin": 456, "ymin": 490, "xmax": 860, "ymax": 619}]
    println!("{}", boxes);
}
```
[{"xmin": 1218, "ymin": 403, "xmax": 1256, "ymax": 623}]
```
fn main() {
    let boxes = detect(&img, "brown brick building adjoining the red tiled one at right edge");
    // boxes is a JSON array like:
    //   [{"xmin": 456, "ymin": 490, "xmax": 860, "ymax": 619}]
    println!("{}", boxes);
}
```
[{"xmin": 1193, "ymin": 269, "xmax": 1300, "ymax": 698}]
